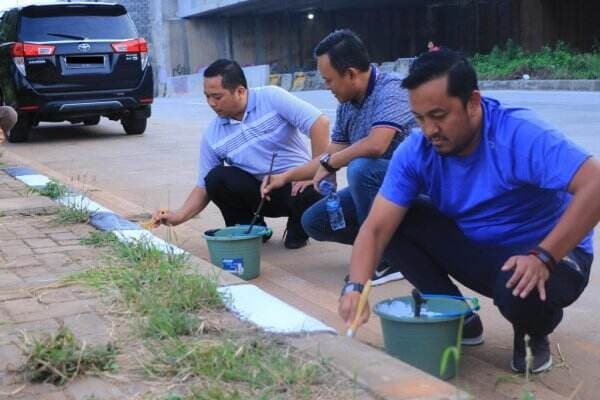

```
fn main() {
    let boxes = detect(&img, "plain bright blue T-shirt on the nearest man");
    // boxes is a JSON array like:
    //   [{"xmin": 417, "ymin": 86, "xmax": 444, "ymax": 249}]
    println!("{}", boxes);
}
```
[{"xmin": 380, "ymin": 98, "xmax": 593, "ymax": 254}]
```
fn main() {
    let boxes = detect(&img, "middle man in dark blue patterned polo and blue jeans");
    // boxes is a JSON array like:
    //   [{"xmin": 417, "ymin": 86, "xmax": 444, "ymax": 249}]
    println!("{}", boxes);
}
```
[{"xmin": 263, "ymin": 30, "xmax": 415, "ymax": 285}]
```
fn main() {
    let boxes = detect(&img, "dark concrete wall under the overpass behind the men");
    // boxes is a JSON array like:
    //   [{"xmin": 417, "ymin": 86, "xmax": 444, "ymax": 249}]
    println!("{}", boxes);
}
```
[{"xmin": 173, "ymin": 0, "xmax": 600, "ymax": 76}]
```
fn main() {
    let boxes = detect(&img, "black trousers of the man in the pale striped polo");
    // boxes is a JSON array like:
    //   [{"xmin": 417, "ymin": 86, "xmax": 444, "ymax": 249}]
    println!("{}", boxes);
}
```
[{"xmin": 204, "ymin": 166, "xmax": 321, "ymax": 235}]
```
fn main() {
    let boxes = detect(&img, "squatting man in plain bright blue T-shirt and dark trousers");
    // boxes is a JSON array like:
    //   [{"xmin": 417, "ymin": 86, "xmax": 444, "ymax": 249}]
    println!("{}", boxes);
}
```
[{"xmin": 339, "ymin": 50, "xmax": 600, "ymax": 372}]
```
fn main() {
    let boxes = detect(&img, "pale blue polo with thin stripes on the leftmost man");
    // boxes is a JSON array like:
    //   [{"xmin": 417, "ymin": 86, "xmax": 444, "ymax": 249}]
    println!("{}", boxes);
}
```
[{"xmin": 196, "ymin": 86, "xmax": 322, "ymax": 187}]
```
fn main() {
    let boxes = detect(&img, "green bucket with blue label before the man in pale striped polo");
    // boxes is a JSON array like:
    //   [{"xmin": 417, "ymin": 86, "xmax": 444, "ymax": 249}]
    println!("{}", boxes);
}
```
[{"xmin": 202, "ymin": 225, "xmax": 271, "ymax": 280}]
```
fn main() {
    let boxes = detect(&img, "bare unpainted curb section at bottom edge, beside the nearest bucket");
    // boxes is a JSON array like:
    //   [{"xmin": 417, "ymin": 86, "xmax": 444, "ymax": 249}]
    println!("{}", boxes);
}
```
[{"xmin": 290, "ymin": 334, "xmax": 468, "ymax": 400}]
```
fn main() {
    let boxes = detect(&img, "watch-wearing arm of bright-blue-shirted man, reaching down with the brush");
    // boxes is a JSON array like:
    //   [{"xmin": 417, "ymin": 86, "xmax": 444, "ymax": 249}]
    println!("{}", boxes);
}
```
[{"xmin": 338, "ymin": 194, "xmax": 407, "ymax": 325}]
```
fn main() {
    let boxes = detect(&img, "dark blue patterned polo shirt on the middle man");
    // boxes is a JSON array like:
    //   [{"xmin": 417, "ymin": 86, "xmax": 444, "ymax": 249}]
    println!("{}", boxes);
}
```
[{"xmin": 331, "ymin": 65, "xmax": 416, "ymax": 159}]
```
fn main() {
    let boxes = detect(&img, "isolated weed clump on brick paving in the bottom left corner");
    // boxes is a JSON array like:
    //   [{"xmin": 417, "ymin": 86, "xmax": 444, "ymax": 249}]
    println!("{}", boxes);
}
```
[{"xmin": 19, "ymin": 326, "xmax": 117, "ymax": 385}]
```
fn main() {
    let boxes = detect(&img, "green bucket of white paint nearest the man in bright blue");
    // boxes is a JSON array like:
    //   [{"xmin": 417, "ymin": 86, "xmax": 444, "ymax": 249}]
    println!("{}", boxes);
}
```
[{"xmin": 374, "ymin": 295, "xmax": 479, "ymax": 379}]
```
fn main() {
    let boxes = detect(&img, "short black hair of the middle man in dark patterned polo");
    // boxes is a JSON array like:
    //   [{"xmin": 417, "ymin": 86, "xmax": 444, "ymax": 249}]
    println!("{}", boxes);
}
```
[{"xmin": 314, "ymin": 29, "xmax": 371, "ymax": 75}]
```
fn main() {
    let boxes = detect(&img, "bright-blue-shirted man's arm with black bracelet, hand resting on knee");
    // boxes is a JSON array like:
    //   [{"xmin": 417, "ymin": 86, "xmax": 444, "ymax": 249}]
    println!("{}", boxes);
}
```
[{"xmin": 502, "ymin": 158, "xmax": 600, "ymax": 300}]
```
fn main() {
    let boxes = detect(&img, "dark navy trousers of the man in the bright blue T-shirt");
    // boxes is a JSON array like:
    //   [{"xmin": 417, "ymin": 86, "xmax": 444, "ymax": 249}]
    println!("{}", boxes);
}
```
[{"xmin": 385, "ymin": 201, "xmax": 593, "ymax": 335}]
